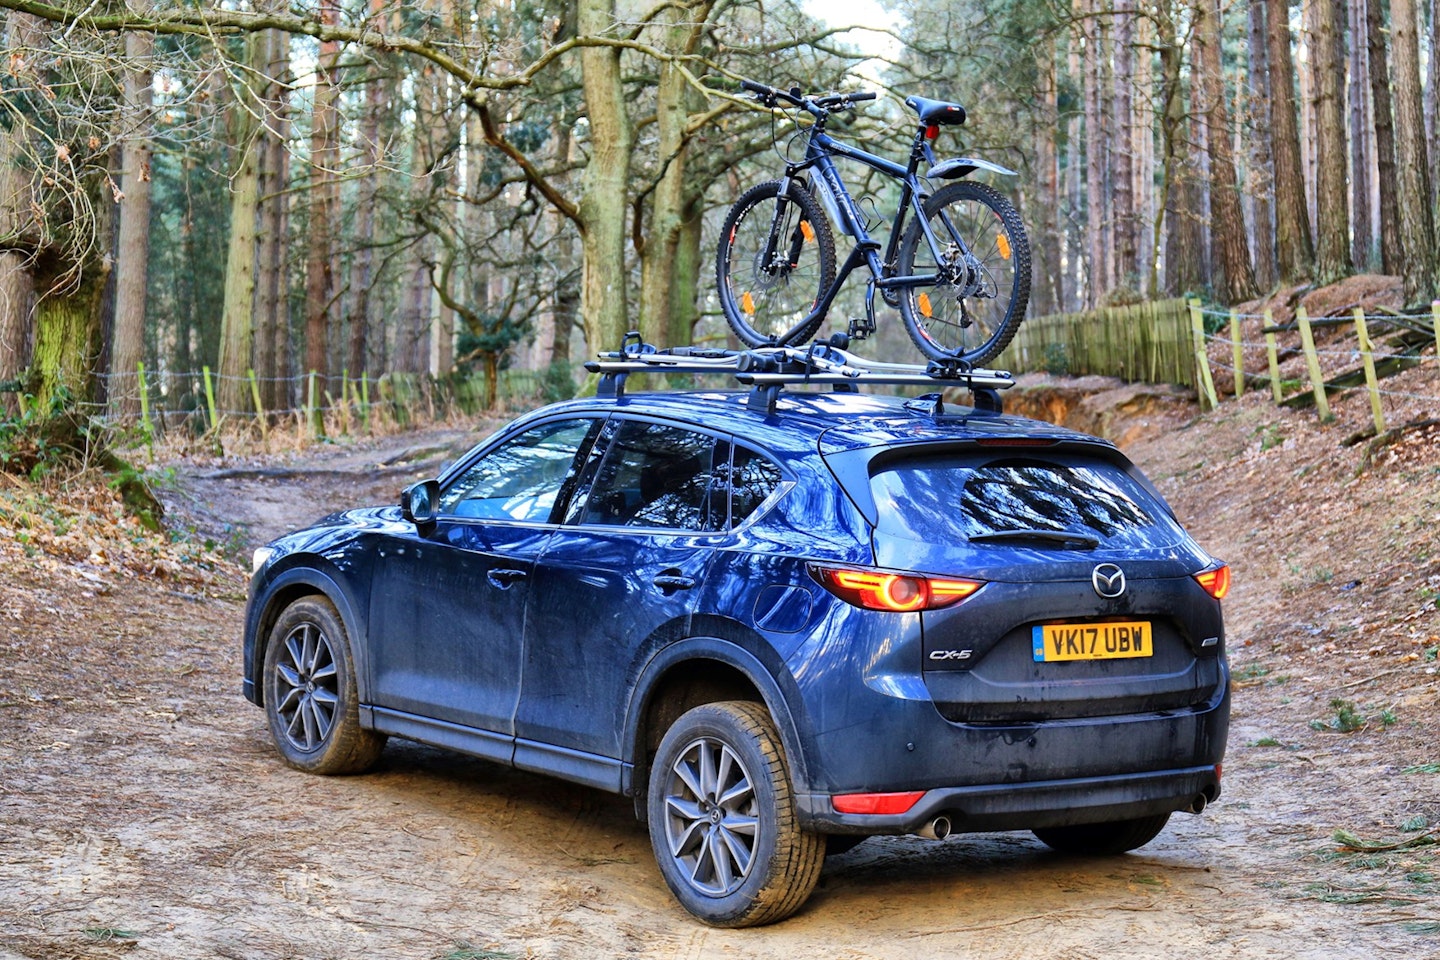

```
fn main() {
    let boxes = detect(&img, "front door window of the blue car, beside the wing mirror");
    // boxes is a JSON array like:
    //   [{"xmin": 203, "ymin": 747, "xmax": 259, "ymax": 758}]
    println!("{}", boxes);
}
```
[{"xmin": 439, "ymin": 419, "xmax": 598, "ymax": 524}]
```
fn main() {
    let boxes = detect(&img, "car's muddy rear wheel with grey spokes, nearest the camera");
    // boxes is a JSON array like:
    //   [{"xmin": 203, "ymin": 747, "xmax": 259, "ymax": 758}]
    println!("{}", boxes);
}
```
[{"xmin": 649, "ymin": 701, "xmax": 825, "ymax": 927}]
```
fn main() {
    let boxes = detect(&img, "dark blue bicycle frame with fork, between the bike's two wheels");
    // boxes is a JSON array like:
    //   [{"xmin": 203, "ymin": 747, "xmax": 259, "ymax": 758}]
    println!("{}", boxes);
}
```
[{"xmin": 765, "ymin": 117, "xmax": 969, "ymax": 343}]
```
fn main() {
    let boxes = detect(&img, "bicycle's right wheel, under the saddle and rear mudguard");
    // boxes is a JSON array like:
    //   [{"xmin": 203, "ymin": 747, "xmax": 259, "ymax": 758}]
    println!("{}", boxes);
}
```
[{"xmin": 896, "ymin": 180, "xmax": 1030, "ymax": 367}]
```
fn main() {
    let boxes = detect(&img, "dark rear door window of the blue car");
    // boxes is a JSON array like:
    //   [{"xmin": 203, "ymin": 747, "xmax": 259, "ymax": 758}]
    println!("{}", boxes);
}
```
[{"xmin": 579, "ymin": 420, "xmax": 723, "ymax": 531}]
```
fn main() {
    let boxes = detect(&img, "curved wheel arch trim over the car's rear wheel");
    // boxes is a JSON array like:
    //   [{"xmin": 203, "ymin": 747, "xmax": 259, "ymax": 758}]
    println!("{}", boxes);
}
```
[{"xmin": 622, "ymin": 636, "xmax": 809, "ymax": 813}]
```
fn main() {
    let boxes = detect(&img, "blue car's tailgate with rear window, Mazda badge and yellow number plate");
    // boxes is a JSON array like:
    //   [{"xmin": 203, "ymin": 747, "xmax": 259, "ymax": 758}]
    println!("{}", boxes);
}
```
[{"xmin": 867, "ymin": 440, "xmax": 1224, "ymax": 724}]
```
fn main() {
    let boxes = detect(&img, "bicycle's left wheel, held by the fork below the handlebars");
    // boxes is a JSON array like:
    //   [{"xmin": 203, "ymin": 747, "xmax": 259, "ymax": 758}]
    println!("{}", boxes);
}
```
[{"xmin": 716, "ymin": 180, "xmax": 835, "ymax": 347}]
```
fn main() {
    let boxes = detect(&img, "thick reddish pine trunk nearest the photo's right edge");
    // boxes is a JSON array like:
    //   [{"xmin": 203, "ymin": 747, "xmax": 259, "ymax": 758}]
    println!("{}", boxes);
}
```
[{"xmin": 1390, "ymin": 0, "xmax": 1436, "ymax": 304}]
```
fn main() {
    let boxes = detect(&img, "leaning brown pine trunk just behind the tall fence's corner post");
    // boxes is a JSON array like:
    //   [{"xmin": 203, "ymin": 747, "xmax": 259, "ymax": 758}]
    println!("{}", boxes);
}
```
[{"xmin": 1195, "ymin": 0, "xmax": 1256, "ymax": 304}]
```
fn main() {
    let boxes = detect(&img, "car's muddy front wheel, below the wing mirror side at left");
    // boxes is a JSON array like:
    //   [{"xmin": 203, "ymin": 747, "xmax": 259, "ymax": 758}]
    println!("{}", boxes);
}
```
[{"xmin": 264, "ymin": 596, "xmax": 384, "ymax": 774}]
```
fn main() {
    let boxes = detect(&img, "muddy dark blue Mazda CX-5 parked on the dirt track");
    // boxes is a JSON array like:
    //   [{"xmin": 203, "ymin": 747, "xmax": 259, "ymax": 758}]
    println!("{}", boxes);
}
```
[{"xmin": 245, "ymin": 391, "xmax": 1230, "ymax": 927}]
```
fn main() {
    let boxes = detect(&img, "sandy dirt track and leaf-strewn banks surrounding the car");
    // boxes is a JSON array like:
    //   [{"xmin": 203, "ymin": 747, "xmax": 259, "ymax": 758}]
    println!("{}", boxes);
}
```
[{"xmin": 0, "ymin": 356, "xmax": 1440, "ymax": 960}]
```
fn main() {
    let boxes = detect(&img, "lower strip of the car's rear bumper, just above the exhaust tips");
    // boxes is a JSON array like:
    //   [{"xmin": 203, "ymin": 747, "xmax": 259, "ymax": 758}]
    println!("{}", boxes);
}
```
[{"xmin": 796, "ymin": 764, "xmax": 1220, "ymax": 833}]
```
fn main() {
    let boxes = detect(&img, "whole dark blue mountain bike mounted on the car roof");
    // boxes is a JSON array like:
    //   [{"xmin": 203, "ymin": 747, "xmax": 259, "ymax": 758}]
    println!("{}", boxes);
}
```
[{"xmin": 716, "ymin": 79, "xmax": 1030, "ymax": 367}]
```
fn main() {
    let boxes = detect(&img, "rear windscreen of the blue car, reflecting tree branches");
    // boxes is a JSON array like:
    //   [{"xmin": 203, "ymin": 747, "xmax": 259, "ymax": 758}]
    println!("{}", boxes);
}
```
[{"xmin": 870, "ymin": 453, "xmax": 1181, "ymax": 547}]
